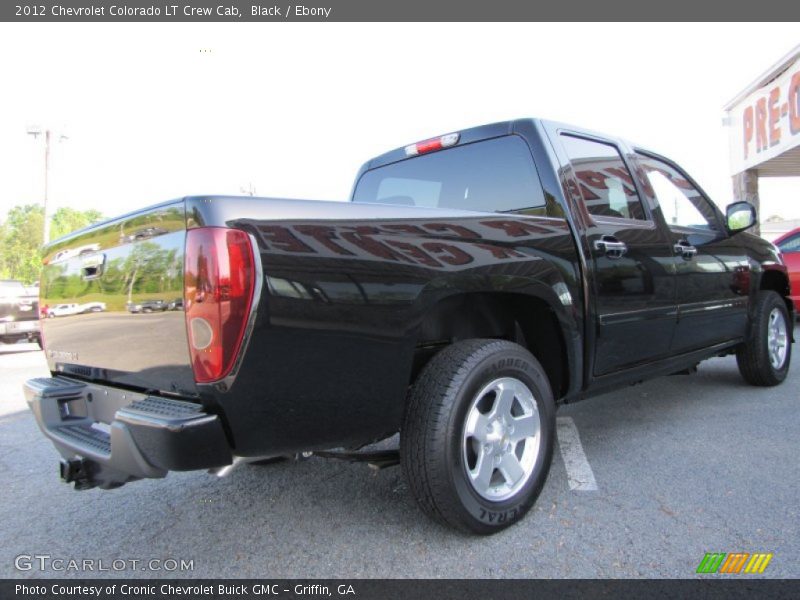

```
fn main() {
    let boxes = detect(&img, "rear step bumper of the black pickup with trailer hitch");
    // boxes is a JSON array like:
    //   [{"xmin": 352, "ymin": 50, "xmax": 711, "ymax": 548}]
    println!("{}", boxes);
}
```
[{"xmin": 25, "ymin": 377, "xmax": 232, "ymax": 489}]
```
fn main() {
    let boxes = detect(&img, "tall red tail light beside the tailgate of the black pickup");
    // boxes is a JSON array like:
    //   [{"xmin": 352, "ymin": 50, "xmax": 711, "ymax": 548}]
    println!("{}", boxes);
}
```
[{"xmin": 184, "ymin": 227, "xmax": 256, "ymax": 383}]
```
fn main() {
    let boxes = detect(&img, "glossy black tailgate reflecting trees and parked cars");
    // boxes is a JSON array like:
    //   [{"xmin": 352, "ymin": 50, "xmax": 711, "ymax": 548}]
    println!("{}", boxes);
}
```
[{"xmin": 40, "ymin": 200, "xmax": 196, "ymax": 396}]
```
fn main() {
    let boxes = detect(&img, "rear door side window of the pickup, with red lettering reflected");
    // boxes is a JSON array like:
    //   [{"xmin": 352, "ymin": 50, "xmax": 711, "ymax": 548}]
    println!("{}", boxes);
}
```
[{"xmin": 561, "ymin": 134, "xmax": 647, "ymax": 220}]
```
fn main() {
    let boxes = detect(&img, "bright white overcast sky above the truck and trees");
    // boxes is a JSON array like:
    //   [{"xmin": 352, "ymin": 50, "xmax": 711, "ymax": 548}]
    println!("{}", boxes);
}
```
[{"xmin": 0, "ymin": 23, "xmax": 800, "ymax": 223}]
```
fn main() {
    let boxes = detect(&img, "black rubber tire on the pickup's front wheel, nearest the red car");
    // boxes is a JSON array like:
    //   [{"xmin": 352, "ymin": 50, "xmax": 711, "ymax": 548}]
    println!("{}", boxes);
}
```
[{"xmin": 736, "ymin": 290, "xmax": 793, "ymax": 387}]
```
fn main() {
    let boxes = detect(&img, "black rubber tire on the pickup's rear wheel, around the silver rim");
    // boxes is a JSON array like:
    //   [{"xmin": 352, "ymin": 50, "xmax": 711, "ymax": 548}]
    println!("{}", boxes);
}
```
[{"xmin": 400, "ymin": 340, "xmax": 556, "ymax": 535}]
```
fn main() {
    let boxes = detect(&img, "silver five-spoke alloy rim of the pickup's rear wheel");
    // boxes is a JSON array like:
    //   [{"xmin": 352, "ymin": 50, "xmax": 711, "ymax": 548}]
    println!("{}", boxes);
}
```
[{"xmin": 461, "ymin": 377, "xmax": 541, "ymax": 502}]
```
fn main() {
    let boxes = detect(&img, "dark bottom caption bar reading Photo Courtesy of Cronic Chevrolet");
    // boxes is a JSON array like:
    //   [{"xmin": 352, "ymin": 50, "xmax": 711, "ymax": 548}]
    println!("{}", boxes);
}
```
[{"xmin": 0, "ymin": 576, "xmax": 800, "ymax": 600}]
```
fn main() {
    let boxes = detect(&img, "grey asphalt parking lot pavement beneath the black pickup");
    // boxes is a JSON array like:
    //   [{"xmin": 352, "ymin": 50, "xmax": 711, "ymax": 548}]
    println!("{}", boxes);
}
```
[{"xmin": 0, "ymin": 330, "xmax": 800, "ymax": 578}]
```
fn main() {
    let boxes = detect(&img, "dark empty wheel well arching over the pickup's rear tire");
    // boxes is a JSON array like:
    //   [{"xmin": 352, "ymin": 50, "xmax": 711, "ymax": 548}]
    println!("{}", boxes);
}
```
[{"xmin": 411, "ymin": 293, "xmax": 569, "ymax": 398}]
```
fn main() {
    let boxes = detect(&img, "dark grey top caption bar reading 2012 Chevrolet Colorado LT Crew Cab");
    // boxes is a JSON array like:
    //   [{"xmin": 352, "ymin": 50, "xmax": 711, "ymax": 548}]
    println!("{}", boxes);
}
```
[{"xmin": 0, "ymin": 0, "xmax": 800, "ymax": 21}]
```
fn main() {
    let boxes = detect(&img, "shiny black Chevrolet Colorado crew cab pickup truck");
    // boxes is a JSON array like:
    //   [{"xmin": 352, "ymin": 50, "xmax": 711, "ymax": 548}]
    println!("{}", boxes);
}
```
[{"xmin": 26, "ymin": 119, "xmax": 794, "ymax": 534}]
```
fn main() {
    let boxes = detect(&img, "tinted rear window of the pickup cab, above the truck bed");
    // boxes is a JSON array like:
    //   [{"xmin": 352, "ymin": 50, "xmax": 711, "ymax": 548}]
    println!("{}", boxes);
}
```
[{"xmin": 353, "ymin": 135, "xmax": 545, "ymax": 212}]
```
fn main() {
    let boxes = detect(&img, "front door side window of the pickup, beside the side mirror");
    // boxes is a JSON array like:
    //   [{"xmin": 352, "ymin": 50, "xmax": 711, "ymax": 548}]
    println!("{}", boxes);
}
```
[{"xmin": 638, "ymin": 154, "xmax": 719, "ymax": 231}]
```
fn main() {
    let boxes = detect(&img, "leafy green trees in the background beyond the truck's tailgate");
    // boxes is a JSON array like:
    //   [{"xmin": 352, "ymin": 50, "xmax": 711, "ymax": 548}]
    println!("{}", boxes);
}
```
[{"xmin": 0, "ymin": 204, "xmax": 103, "ymax": 283}]
